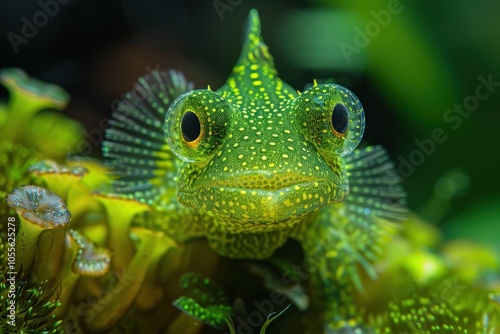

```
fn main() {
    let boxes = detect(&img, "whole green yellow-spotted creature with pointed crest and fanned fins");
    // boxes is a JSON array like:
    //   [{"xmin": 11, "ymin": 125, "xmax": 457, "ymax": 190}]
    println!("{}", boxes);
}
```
[{"xmin": 103, "ymin": 10, "xmax": 405, "ymax": 330}]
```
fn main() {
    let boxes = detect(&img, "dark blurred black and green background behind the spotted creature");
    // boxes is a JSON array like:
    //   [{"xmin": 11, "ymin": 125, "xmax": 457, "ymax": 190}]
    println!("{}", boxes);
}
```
[{"xmin": 0, "ymin": 0, "xmax": 500, "ymax": 248}]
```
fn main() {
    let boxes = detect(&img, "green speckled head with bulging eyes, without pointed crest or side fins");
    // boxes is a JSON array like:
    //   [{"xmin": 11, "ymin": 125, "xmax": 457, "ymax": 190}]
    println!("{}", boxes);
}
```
[{"xmin": 165, "ymin": 84, "xmax": 364, "ymax": 231}]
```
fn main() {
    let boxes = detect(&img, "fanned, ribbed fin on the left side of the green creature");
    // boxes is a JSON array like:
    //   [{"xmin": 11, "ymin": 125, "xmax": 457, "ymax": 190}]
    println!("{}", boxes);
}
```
[{"xmin": 103, "ymin": 70, "xmax": 193, "ymax": 206}]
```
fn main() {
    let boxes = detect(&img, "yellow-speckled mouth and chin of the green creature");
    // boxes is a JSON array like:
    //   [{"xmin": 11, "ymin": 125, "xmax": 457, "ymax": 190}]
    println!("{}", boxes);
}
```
[{"xmin": 178, "ymin": 176, "xmax": 347, "ymax": 231}]
